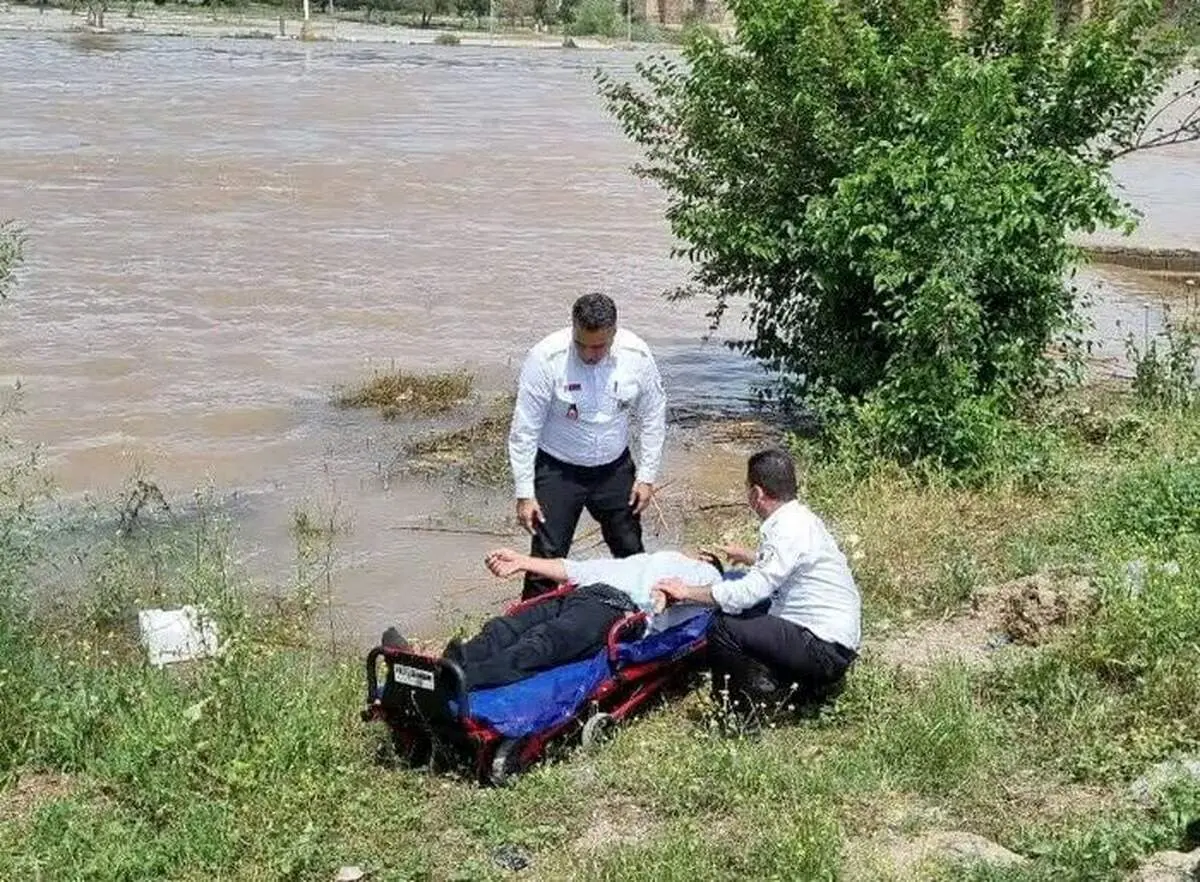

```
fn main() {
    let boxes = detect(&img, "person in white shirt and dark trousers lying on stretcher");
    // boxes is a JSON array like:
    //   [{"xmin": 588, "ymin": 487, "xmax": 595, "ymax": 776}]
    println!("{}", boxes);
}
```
[{"xmin": 383, "ymin": 548, "xmax": 724, "ymax": 689}]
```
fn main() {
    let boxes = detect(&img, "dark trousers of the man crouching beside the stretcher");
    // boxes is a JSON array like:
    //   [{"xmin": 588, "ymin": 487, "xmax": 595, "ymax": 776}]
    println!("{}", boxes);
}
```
[{"xmin": 708, "ymin": 601, "xmax": 857, "ymax": 709}]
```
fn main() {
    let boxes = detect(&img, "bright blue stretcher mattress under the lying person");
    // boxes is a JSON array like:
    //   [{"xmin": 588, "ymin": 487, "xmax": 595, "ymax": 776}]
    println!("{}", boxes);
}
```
[{"xmin": 467, "ymin": 610, "xmax": 713, "ymax": 738}]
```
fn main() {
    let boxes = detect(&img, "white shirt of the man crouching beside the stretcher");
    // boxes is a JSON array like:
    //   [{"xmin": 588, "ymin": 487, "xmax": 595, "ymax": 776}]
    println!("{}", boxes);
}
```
[{"xmin": 712, "ymin": 499, "xmax": 862, "ymax": 652}]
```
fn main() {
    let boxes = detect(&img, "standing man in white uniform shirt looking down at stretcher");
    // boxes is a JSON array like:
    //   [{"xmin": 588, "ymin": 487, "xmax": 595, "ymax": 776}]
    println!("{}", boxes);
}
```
[{"xmin": 509, "ymin": 294, "xmax": 666, "ymax": 599}]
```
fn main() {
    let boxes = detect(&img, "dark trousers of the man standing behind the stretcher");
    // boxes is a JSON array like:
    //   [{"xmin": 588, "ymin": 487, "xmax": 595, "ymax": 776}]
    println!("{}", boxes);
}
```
[{"xmin": 521, "ymin": 450, "xmax": 644, "ymax": 600}]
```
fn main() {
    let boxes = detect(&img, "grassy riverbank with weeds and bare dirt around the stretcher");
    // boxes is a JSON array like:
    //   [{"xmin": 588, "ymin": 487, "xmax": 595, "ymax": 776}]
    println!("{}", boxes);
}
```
[{"xmin": 0, "ymin": 376, "xmax": 1200, "ymax": 881}]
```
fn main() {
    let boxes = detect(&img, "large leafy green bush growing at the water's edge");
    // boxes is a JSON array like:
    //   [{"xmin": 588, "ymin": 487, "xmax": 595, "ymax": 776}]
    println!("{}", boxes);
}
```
[{"xmin": 600, "ymin": 0, "xmax": 1198, "ymax": 469}]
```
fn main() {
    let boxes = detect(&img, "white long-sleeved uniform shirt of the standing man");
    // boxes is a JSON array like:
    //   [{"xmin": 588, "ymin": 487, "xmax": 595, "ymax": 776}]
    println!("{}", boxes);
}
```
[{"xmin": 509, "ymin": 328, "xmax": 667, "ymax": 499}]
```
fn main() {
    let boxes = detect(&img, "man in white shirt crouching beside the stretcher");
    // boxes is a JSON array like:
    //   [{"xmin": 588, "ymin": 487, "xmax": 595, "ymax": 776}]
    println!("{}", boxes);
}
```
[{"xmin": 654, "ymin": 450, "xmax": 862, "ymax": 708}]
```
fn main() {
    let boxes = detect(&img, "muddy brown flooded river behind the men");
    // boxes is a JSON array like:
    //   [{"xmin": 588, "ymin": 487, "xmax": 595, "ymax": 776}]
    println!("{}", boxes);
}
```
[{"xmin": 0, "ymin": 35, "xmax": 1200, "ymax": 636}]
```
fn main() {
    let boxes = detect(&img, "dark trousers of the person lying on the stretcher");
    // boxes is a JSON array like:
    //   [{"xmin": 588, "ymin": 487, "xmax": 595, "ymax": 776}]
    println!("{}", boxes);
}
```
[{"xmin": 445, "ymin": 584, "xmax": 636, "ymax": 689}]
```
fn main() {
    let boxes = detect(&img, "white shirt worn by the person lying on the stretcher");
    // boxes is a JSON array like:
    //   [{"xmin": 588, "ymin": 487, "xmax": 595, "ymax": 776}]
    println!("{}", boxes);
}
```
[{"xmin": 563, "ymin": 551, "xmax": 721, "ymax": 631}]
